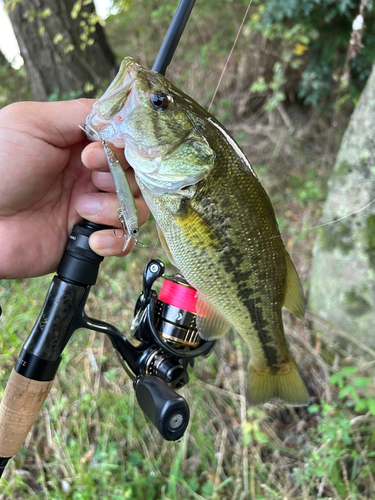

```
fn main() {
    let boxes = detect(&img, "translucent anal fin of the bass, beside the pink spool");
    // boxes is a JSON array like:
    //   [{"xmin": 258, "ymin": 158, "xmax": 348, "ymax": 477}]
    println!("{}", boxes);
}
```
[{"xmin": 196, "ymin": 291, "xmax": 232, "ymax": 340}]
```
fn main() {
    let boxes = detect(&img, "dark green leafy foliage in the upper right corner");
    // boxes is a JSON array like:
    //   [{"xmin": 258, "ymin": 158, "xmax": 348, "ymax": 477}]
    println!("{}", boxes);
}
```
[{"xmin": 257, "ymin": 0, "xmax": 375, "ymax": 109}]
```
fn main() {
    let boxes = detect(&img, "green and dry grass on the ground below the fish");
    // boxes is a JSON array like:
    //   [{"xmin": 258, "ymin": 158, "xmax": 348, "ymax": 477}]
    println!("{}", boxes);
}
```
[{"xmin": 0, "ymin": 213, "xmax": 375, "ymax": 500}]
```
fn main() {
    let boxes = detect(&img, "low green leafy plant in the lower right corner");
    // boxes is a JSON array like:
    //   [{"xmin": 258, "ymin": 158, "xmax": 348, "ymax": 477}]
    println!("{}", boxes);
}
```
[{"xmin": 294, "ymin": 366, "xmax": 375, "ymax": 499}]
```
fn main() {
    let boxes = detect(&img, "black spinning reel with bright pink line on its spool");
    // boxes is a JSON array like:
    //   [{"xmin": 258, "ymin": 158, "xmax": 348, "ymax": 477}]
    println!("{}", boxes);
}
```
[{"xmin": 125, "ymin": 260, "xmax": 214, "ymax": 441}]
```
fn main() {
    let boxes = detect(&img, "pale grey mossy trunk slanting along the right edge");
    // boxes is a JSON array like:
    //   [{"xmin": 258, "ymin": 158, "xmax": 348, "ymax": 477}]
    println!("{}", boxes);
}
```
[{"xmin": 309, "ymin": 65, "xmax": 375, "ymax": 348}]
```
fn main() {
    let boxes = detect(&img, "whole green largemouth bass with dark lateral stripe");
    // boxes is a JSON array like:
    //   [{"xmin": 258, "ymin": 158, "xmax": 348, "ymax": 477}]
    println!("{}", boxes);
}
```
[{"xmin": 87, "ymin": 57, "xmax": 309, "ymax": 406}]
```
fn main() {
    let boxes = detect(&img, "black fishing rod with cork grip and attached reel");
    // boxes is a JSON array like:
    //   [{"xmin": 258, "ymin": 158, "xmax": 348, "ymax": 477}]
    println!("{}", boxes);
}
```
[{"xmin": 0, "ymin": 0, "xmax": 215, "ymax": 477}]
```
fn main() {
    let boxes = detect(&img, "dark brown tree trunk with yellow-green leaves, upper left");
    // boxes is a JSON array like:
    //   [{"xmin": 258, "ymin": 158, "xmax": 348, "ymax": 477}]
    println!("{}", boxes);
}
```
[{"xmin": 8, "ymin": 0, "xmax": 116, "ymax": 101}]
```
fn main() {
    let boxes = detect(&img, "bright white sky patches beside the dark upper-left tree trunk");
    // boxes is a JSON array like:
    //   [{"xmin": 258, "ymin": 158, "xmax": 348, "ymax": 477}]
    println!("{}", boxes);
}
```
[{"xmin": 0, "ymin": 0, "xmax": 111, "ymax": 68}]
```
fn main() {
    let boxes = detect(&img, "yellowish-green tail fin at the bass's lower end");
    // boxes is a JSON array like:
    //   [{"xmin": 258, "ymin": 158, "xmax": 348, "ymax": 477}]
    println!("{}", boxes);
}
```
[{"xmin": 246, "ymin": 355, "xmax": 309, "ymax": 406}]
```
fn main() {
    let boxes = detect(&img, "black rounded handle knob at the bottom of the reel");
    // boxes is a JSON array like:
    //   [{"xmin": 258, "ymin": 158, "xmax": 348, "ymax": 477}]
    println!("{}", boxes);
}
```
[{"xmin": 134, "ymin": 375, "xmax": 190, "ymax": 441}]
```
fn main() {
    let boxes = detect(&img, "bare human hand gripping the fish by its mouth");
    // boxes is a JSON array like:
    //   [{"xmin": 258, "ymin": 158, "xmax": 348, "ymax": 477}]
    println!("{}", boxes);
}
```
[{"xmin": 0, "ymin": 99, "xmax": 148, "ymax": 279}]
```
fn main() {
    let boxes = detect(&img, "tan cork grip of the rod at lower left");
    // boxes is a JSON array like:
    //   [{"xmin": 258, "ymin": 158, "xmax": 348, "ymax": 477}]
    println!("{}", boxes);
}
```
[{"xmin": 0, "ymin": 369, "xmax": 53, "ymax": 457}]
